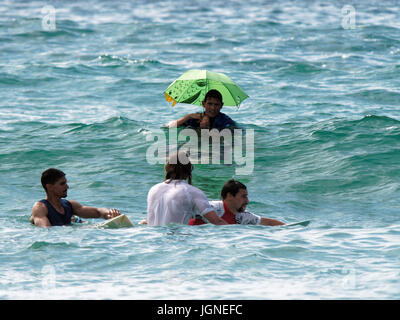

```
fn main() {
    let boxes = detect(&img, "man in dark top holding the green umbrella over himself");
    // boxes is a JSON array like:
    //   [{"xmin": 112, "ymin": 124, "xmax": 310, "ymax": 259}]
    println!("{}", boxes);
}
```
[{"xmin": 167, "ymin": 90, "xmax": 236, "ymax": 130}]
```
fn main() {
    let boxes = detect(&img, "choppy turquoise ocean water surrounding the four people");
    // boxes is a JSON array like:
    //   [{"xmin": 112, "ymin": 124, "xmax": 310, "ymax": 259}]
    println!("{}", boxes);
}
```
[{"xmin": 0, "ymin": 0, "xmax": 400, "ymax": 299}]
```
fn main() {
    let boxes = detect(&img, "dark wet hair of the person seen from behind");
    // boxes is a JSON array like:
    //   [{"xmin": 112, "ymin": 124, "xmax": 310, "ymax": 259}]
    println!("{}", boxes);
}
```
[{"xmin": 164, "ymin": 152, "xmax": 193, "ymax": 184}]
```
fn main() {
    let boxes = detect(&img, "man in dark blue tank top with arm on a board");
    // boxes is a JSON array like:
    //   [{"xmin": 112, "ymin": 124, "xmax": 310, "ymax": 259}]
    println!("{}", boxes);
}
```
[{"xmin": 30, "ymin": 168, "xmax": 120, "ymax": 227}]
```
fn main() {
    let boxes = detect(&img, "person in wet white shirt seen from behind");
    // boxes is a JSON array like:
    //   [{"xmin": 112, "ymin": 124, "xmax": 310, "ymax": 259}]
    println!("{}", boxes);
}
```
[{"xmin": 147, "ymin": 152, "xmax": 227, "ymax": 226}]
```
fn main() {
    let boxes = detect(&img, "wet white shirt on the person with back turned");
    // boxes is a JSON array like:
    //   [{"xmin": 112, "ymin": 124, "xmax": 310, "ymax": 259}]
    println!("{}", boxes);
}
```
[{"xmin": 147, "ymin": 180, "xmax": 215, "ymax": 226}]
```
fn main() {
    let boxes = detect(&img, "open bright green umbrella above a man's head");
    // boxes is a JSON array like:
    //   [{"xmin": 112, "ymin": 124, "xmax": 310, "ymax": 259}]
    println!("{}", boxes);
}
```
[{"xmin": 164, "ymin": 69, "xmax": 248, "ymax": 106}]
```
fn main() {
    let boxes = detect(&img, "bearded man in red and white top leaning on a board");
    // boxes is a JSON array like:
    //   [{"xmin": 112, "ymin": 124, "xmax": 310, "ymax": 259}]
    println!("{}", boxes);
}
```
[{"xmin": 189, "ymin": 179, "xmax": 284, "ymax": 226}]
